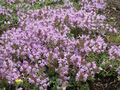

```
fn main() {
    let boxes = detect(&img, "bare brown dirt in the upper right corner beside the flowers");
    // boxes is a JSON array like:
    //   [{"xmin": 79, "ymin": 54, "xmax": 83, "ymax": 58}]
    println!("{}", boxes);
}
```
[{"xmin": 102, "ymin": 0, "xmax": 120, "ymax": 32}]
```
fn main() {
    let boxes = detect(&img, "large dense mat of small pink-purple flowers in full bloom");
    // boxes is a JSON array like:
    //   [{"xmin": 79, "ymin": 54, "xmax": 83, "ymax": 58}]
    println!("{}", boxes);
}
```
[{"xmin": 0, "ymin": 0, "xmax": 120, "ymax": 90}]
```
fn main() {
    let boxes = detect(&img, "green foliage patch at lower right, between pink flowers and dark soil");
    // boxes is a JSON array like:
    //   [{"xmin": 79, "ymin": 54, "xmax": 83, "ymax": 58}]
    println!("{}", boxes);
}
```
[{"xmin": 86, "ymin": 52, "xmax": 120, "ymax": 76}]
